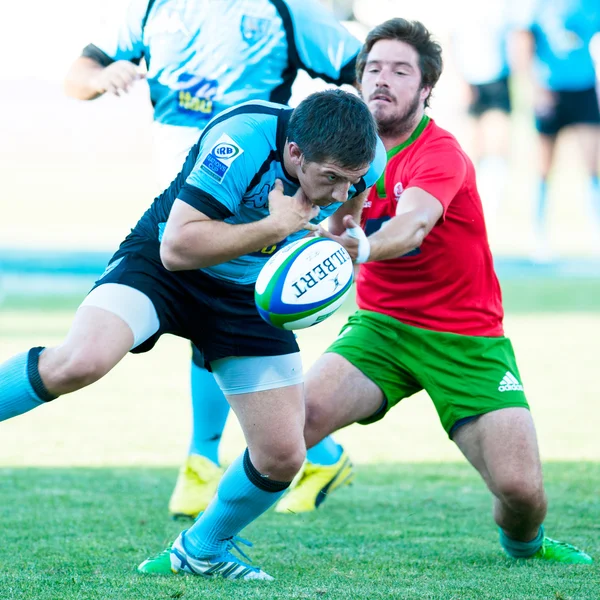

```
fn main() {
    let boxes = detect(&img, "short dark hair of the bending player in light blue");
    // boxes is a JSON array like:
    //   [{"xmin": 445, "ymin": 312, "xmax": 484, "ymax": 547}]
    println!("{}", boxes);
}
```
[{"xmin": 287, "ymin": 89, "xmax": 377, "ymax": 169}]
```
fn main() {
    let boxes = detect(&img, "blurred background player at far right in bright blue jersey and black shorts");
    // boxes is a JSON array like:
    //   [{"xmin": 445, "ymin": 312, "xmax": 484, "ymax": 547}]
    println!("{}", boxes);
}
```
[{"xmin": 516, "ymin": 0, "xmax": 600, "ymax": 260}]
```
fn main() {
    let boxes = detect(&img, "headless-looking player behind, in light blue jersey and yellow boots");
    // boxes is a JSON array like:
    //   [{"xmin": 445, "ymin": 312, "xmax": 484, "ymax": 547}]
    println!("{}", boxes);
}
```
[{"xmin": 65, "ymin": 0, "xmax": 360, "ymax": 517}]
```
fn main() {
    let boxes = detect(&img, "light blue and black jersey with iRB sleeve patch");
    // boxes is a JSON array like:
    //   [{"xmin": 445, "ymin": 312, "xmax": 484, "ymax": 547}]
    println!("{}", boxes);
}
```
[{"xmin": 133, "ymin": 101, "xmax": 386, "ymax": 285}]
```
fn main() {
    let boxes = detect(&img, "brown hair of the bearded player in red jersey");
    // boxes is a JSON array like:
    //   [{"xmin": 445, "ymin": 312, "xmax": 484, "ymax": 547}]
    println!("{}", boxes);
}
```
[{"xmin": 356, "ymin": 19, "xmax": 443, "ymax": 106}]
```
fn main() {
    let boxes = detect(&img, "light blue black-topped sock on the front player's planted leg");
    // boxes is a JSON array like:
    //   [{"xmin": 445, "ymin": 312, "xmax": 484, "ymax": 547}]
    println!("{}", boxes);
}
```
[{"xmin": 184, "ymin": 450, "xmax": 291, "ymax": 558}]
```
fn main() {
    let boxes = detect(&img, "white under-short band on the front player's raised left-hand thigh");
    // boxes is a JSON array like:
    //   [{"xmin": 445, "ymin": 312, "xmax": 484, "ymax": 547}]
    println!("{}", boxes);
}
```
[{"xmin": 80, "ymin": 283, "xmax": 160, "ymax": 350}]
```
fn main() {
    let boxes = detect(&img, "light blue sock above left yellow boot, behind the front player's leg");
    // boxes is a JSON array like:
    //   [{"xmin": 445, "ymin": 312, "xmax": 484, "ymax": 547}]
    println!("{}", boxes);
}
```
[{"xmin": 189, "ymin": 362, "xmax": 229, "ymax": 465}]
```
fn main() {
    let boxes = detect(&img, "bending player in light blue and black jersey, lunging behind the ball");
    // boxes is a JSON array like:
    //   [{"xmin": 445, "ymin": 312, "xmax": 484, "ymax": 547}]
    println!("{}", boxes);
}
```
[{"xmin": 0, "ymin": 90, "xmax": 386, "ymax": 579}]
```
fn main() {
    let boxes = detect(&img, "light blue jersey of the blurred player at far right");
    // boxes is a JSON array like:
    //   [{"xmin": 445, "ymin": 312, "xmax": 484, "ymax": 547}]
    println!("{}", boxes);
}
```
[{"xmin": 527, "ymin": 0, "xmax": 600, "ymax": 91}]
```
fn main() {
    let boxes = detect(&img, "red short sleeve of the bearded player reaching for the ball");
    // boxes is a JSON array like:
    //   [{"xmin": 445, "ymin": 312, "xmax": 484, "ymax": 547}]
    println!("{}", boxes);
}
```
[{"xmin": 404, "ymin": 139, "xmax": 467, "ymax": 216}]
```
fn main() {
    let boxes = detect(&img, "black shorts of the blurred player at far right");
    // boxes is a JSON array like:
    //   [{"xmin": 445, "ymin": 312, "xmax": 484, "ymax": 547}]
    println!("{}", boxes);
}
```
[{"xmin": 535, "ymin": 87, "xmax": 600, "ymax": 136}]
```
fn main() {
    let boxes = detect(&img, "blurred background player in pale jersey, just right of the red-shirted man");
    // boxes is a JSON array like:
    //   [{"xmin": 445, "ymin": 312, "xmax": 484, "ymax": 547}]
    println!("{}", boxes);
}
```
[{"xmin": 450, "ymin": 0, "xmax": 511, "ymax": 229}]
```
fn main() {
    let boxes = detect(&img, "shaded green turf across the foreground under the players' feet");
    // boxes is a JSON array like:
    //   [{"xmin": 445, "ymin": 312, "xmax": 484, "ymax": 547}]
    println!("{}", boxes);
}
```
[{"xmin": 0, "ymin": 463, "xmax": 600, "ymax": 600}]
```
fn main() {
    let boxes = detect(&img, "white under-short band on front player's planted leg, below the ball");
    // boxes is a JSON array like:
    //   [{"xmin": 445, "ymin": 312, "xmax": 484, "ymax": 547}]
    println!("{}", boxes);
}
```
[{"xmin": 210, "ymin": 352, "xmax": 304, "ymax": 396}]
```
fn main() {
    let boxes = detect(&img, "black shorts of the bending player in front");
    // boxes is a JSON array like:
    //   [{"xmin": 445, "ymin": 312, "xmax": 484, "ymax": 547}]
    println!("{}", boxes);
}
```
[{"xmin": 94, "ymin": 235, "xmax": 299, "ymax": 364}]
